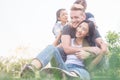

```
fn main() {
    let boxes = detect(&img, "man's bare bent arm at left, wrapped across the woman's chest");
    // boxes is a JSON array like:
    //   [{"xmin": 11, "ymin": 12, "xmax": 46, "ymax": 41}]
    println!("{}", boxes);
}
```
[{"xmin": 61, "ymin": 35, "xmax": 104, "ymax": 55}]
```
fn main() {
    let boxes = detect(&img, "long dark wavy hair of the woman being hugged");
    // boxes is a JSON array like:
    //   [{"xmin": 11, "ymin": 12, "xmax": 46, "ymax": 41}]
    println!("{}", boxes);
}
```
[{"xmin": 79, "ymin": 20, "xmax": 95, "ymax": 46}]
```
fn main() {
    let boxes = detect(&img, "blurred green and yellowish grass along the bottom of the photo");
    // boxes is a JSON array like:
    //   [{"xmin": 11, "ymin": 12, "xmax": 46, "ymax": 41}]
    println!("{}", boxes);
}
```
[{"xmin": 0, "ymin": 56, "xmax": 120, "ymax": 80}]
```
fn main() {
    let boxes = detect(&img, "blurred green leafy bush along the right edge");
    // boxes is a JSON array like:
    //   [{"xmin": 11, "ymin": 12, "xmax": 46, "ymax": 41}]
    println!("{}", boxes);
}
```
[{"xmin": 106, "ymin": 31, "xmax": 120, "ymax": 80}]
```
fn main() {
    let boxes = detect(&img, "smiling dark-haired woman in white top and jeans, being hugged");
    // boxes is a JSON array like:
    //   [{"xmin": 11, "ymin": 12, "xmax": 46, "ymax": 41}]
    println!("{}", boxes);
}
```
[{"xmin": 65, "ymin": 20, "xmax": 100, "ymax": 80}]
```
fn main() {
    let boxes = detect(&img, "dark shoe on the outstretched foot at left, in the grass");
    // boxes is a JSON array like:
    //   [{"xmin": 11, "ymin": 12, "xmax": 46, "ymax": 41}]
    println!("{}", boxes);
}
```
[{"xmin": 20, "ymin": 64, "xmax": 35, "ymax": 78}]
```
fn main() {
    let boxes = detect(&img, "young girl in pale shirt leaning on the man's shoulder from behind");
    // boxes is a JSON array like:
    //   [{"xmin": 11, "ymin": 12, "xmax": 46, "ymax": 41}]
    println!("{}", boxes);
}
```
[{"xmin": 52, "ymin": 8, "xmax": 68, "ymax": 46}]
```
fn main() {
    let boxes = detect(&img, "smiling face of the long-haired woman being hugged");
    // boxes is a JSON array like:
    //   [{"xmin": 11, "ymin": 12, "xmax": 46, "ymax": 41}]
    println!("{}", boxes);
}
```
[{"xmin": 76, "ymin": 22, "xmax": 89, "ymax": 38}]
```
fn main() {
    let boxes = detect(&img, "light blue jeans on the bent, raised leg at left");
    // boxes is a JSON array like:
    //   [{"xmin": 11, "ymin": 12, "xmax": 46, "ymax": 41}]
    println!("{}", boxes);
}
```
[{"xmin": 36, "ymin": 45, "xmax": 67, "ymax": 70}]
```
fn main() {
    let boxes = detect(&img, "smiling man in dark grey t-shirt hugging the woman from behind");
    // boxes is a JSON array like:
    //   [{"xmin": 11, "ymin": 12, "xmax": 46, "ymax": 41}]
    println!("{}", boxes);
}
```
[{"xmin": 20, "ymin": 4, "xmax": 106, "ymax": 76}]
